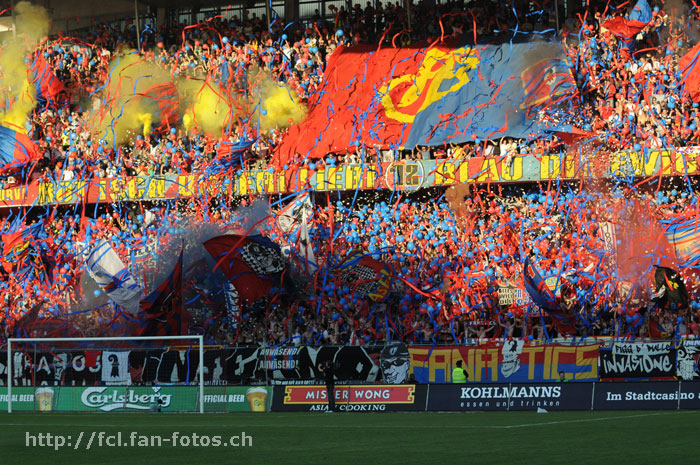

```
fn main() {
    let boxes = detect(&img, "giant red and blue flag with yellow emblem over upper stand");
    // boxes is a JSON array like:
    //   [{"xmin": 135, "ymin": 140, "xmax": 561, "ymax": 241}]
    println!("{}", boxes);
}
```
[{"xmin": 276, "ymin": 43, "xmax": 576, "ymax": 166}]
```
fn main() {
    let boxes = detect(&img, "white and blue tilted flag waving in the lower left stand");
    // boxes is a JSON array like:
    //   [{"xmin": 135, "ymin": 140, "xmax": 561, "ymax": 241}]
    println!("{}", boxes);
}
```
[{"xmin": 83, "ymin": 240, "xmax": 142, "ymax": 314}]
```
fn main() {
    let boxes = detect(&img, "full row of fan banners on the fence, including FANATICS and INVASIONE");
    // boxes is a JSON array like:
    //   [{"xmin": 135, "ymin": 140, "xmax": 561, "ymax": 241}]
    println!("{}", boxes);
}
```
[{"xmin": 0, "ymin": 339, "xmax": 700, "ymax": 386}]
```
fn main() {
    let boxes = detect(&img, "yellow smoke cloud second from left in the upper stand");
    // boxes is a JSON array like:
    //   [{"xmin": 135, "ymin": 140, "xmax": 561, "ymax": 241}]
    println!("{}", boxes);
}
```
[{"xmin": 92, "ymin": 51, "xmax": 172, "ymax": 145}]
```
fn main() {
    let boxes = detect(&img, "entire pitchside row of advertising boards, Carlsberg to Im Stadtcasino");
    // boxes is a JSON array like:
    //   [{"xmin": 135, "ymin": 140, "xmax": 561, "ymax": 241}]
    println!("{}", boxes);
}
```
[{"xmin": 0, "ymin": 381, "xmax": 700, "ymax": 413}]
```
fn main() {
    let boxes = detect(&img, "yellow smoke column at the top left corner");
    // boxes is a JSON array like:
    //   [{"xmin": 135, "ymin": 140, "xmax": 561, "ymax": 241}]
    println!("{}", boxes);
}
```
[{"xmin": 0, "ymin": 2, "xmax": 49, "ymax": 132}]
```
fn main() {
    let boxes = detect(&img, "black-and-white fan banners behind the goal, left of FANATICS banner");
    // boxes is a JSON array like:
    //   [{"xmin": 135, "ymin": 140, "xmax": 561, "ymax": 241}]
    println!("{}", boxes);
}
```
[{"xmin": 0, "ymin": 344, "xmax": 382, "ymax": 386}]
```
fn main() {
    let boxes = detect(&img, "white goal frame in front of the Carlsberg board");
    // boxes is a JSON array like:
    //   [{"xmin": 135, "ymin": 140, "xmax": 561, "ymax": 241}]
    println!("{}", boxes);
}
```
[{"xmin": 7, "ymin": 335, "xmax": 205, "ymax": 413}]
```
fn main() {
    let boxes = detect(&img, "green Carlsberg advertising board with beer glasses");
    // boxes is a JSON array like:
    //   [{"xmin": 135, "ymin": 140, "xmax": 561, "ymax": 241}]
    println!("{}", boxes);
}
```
[{"xmin": 0, "ymin": 386, "xmax": 272, "ymax": 412}]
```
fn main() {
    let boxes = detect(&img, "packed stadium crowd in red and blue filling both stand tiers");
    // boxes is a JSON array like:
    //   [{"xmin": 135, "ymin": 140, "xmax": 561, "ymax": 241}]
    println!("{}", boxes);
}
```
[{"xmin": 0, "ymin": 2, "xmax": 700, "ymax": 344}]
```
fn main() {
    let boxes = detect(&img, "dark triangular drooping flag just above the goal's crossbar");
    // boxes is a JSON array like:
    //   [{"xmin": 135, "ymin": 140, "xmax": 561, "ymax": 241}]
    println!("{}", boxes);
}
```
[{"xmin": 137, "ymin": 251, "xmax": 187, "ymax": 336}]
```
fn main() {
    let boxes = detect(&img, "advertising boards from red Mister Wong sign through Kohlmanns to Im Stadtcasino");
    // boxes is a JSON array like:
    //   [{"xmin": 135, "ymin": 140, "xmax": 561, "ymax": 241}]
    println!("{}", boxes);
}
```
[{"xmin": 272, "ymin": 381, "xmax": 700, "ymax": 412}]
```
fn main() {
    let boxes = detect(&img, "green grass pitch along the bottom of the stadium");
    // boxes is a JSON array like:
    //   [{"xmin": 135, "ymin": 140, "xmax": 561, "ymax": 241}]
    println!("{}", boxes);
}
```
[{"xmin": 0, "ymin": 411, "xmax": 700, "ymax": 465}]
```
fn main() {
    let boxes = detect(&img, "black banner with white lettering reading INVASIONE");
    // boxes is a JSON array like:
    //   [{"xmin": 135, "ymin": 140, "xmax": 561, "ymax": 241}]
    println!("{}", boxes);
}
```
[{"xmin": 598, "ymin": 342, "xmax": 676, "ymax": 379}]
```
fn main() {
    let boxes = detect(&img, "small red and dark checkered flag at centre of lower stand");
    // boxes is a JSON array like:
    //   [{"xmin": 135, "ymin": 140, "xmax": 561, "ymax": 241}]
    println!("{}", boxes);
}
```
[{"xmin": 339, "ymin": 249, "xmax": 394, "ymax": 302}]
